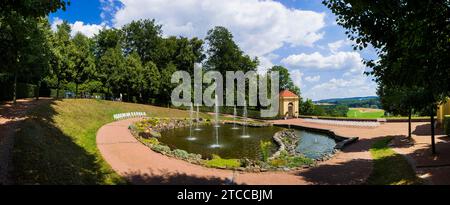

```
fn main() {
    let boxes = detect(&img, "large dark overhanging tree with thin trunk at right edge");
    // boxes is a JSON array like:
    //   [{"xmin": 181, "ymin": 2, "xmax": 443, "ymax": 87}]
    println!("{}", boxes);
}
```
[{"xmin": 323, "ymin": 0, "xmax": 450, "ymax": 153}]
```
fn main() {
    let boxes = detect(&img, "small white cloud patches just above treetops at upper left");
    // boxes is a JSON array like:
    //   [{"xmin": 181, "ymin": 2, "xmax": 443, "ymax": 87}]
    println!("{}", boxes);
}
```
[{"xmin": 51, "ymin": 17, "xmax": 108, "ymax": 37}]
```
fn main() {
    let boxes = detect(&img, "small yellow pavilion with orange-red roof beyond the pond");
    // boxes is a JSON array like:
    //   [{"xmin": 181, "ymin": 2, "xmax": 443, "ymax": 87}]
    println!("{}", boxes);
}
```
[{"xmin": 278, "ymin": 90, "xmax": 300, "ymax": 118}]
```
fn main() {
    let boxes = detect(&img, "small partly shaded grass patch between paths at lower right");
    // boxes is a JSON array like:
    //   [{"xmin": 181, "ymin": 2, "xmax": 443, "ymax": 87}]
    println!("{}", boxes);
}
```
[{"xmin": 368, "ymin": 137, "xmax": 421, "ymax": 185}]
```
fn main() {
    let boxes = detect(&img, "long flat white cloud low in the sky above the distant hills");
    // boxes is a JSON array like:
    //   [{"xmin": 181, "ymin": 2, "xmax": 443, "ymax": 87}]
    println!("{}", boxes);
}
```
[{"xmin": 281, "ymin": 52, "xmax": 364, "ymax": 73}]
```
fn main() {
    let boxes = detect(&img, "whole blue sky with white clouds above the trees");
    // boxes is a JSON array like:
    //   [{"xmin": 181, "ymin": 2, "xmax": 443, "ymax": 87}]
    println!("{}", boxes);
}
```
[{"xmin": 50, "ymin": 0, "xmax": 376, "ymax": 100}]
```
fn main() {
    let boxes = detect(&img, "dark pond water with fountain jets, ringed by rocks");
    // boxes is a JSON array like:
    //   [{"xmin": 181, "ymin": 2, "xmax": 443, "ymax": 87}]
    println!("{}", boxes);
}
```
[{"xmin": 160, "ymin": 124, "xmax": 335, "ymax": 160}]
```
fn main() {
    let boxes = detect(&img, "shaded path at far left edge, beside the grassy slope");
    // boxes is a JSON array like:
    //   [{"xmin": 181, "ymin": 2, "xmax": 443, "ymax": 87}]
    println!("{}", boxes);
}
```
[{"xmin": 0, "ymin": 98, "xmax": 50, "ymax": 185}]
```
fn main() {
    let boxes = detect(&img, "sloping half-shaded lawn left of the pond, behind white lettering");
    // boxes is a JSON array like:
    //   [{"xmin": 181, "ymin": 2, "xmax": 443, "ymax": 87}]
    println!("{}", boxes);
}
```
[{"xmin": 12, "ymin": 100, "xmax": 210, "ymax": 184}]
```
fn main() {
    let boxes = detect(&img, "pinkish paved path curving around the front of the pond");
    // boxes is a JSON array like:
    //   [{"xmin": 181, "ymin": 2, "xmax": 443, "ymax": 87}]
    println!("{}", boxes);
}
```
[{"xmin": 97, "ymin": 119, "xmax": 448, "ymax": 185}]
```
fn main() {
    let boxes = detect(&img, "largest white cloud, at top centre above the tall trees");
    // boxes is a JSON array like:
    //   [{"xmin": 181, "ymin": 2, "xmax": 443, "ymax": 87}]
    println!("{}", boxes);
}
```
[{"xmin": 110, "ymin": 0, "xmax": 325, "ymax": 69}]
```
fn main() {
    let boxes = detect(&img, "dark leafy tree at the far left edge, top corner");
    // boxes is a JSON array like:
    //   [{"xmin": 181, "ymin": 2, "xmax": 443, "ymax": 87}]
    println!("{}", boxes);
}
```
[{"xmin": 0, "ymin": 0, "xmax": 67, "ymax": 103}]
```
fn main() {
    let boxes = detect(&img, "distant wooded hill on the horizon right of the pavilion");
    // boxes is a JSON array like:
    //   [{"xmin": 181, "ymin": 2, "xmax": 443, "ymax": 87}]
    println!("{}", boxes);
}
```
[{"xmin": 314, "ymin": 96, "xmax": 381, "ymax": 108}]
